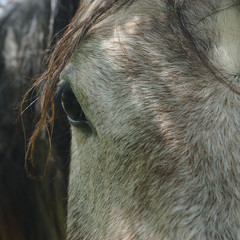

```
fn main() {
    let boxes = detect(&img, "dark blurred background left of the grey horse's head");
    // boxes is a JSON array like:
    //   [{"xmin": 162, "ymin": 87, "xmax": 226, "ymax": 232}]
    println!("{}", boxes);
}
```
[{"xmin": 0, "ymin": 0, "xmax": 79, "ymax": 240}]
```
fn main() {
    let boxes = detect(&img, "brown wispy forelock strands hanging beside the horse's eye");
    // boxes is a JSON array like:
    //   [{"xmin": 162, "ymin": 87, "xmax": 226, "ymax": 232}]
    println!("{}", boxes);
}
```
[{"xmin": 20, "ymin": 0, "xmax": 134, "ymax": 168}]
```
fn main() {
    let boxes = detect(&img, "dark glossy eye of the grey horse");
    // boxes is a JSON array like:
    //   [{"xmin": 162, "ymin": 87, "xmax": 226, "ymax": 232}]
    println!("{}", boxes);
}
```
[{"xmin": 61, "ymin": 89, "xmax": 87, "ymax": 124}]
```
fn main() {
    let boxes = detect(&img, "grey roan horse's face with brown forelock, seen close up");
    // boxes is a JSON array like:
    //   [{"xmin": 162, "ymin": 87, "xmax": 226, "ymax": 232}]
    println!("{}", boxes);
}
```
[{"xmin": 25, "ymin": 0, "xmax": 240, "ymax": 240}]
